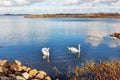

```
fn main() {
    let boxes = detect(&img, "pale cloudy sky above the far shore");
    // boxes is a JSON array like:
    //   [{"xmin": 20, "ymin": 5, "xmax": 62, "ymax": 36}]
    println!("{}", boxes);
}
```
[{"xmin": 0, "ymin": 0, "xmax": 120, "ymax": 14}]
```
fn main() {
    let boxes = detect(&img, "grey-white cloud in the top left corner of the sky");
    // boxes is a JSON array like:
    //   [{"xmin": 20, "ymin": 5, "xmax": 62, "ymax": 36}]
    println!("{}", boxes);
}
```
[{"xmin": 0, "ymin": 0, "xmax": 44, "ymax": 7}]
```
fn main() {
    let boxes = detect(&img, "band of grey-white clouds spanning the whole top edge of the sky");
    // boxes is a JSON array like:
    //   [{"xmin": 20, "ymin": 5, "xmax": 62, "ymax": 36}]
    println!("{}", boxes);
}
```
[{"xmin": 0, "ymin": 0, "xmax": 120, "ymax": 6}]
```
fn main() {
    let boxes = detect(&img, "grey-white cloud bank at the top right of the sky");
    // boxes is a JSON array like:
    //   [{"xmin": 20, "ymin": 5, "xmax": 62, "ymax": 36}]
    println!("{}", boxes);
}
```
[{"xmin": 64, "ymin": 0, "xmax": 120, "ymax": 6}]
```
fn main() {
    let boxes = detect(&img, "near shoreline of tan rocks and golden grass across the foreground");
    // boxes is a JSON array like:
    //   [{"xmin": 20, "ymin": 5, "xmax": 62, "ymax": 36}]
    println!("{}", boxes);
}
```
[{"xmin": 0, "ymin": 59, "xmax": 120, "ymax": 80}]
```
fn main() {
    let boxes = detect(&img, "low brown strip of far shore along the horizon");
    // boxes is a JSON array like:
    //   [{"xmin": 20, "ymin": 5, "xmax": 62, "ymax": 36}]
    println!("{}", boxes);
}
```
[{"xmin": 24, "ymin": 13, "xmax": 120, "ymax": 18}]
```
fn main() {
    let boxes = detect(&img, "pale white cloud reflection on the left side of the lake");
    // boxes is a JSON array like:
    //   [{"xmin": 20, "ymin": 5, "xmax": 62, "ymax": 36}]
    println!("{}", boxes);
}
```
[{"xmin": 0, "ymin": 18, "xmax": 51, "ymax": 45}]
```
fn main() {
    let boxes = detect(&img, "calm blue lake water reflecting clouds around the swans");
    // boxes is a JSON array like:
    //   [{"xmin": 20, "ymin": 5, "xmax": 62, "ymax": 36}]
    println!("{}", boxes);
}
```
[{"xmin": 0, "ymin": 16, "xmax": 120, "ymax": 74}]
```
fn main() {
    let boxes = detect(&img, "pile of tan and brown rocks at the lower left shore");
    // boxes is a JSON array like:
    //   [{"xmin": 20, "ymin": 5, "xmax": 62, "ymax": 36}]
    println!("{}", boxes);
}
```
[{"xmin": 0, "ymin": 60, "xmax": 51, "ymax": 80}]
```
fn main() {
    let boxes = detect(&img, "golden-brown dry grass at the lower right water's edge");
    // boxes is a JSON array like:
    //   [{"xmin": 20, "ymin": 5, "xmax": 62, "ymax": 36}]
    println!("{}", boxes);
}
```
[{"xmin": 68, "ymin": 60, "xmax": 120, "ymax": 80}]
